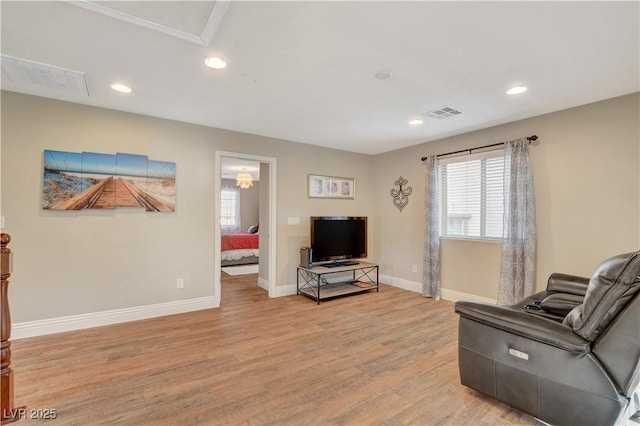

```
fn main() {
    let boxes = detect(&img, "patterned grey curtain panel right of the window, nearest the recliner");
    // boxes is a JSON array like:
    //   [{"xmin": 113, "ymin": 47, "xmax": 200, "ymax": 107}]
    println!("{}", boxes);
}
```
[{"xmin": 498, "ymin": 139, "xmax": 536, "ymax": 305}]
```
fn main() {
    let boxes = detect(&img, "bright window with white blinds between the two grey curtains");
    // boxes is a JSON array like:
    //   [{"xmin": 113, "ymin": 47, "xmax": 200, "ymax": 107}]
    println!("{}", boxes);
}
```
[{"xmin": 438, "ymin": 150, "xmax": 504, "ymax": 239}]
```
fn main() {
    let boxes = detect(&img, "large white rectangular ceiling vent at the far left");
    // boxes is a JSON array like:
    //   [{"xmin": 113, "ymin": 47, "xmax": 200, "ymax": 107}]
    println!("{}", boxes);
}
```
[{"xmin": 2, "ymin": 55, "xmax": 89, "ymax": 96}]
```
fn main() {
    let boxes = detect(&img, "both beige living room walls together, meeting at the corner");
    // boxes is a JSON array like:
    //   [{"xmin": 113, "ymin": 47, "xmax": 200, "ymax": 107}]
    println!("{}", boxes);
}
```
[{"xmin": 0, "ymin": 92, "xmax": 640, "ymax": 322}]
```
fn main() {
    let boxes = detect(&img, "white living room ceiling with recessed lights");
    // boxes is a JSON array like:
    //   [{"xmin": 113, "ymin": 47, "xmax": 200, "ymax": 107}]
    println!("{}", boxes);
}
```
[{"xmin": 0, "ymin": 0, "xmax": 640, "ymax": 154}]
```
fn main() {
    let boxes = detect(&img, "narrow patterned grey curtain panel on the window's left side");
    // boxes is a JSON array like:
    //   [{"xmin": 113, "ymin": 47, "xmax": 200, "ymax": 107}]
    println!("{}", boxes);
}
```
[{"xmin": 422, "ymin": 155, "xmax": 440, "ymax": 300}]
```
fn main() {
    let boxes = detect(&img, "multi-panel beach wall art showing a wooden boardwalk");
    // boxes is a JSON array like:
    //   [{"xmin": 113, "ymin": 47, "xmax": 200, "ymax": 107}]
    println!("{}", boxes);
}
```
[{"xmin": 42, "ymin": 150, "xmax": 176, "ymax": 212}]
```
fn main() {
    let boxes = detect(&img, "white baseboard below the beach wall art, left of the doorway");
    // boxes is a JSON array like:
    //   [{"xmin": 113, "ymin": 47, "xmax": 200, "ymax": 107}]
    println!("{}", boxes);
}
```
[{"xmin": 11, "ymin": 296, "xmax": 220, "ymax": 340}]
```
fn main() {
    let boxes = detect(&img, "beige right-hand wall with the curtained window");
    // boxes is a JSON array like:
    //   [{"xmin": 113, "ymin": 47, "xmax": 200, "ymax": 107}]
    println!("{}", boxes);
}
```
[{"xmin": 373, "ymin": 93, "xmax": 640, "ymax": 299}]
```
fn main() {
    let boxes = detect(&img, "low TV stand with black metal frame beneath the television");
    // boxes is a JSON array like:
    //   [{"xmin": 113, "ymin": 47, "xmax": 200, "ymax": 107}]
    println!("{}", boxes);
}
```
[{"xmin": 296, "ymin": 261, "xmax": 380, "ymax": 305}]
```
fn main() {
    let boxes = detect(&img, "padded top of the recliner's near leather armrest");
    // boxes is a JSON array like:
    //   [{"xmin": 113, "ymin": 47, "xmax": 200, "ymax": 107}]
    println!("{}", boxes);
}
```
[{"xmin": 455, "ymin": 301, "xmax": 591, "ymax": 354}]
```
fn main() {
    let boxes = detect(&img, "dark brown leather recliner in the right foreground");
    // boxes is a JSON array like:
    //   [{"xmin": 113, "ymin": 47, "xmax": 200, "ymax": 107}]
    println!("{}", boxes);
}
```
[{"xmin": 455, "ymin": 251, "xmax": 640, "ymax": 425}]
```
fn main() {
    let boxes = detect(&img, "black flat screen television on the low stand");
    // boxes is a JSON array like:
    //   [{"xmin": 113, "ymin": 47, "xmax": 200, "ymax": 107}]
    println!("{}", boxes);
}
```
[{"xmin": 311, "ymin": 216, "xmax": 367, "ymax": 266}]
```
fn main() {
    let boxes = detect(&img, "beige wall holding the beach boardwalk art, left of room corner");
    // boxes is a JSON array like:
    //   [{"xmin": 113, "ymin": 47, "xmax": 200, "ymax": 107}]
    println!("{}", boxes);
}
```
[{"xmin": 0, "ymin": 92, "xmax": 372, "ymax": 323}]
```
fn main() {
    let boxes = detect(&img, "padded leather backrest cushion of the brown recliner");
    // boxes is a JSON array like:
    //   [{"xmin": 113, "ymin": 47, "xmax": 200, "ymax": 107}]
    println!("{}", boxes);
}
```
[{"xmin": 563, "ymin": 252, "xmax": 640, "ymax": 342}]
